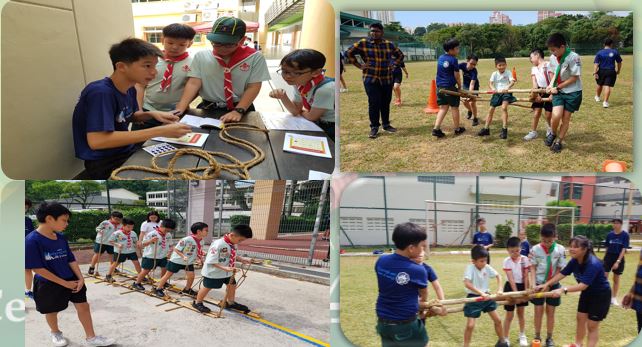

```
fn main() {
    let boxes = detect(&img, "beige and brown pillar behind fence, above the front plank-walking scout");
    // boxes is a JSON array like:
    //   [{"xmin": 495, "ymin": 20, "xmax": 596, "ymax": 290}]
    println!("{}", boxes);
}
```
[{"xmin": 250, "ymin": 180, "xmax": 285, "ymax": 240}]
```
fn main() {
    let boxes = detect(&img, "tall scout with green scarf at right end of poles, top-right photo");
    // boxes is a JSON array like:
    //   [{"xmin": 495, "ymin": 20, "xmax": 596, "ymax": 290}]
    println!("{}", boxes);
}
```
[{"xmin": 545, "ymin": 33, "xmax": 582, "ymax": 153}]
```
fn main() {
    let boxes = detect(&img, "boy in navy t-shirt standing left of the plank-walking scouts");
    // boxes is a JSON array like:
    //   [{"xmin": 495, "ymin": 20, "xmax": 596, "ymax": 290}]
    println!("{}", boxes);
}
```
[{"xmin": 25, "ymin": 202, "xmax": 115, "ymax": 346}]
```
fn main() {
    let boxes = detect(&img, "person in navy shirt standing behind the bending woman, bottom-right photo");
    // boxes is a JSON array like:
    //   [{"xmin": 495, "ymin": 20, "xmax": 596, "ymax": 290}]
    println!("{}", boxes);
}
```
[{"xmin": 604, "ymin": 218, "xmax": 630, "ymax": 306}]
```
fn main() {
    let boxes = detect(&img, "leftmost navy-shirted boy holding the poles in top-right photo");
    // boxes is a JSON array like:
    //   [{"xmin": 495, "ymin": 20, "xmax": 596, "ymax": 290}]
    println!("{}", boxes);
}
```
[{"xmin": 432, "ymin": 39, "xmax": 466, "ymax": 138}]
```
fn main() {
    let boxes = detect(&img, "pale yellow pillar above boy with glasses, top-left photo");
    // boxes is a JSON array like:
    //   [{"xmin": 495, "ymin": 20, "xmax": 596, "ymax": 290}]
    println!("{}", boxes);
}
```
[{"xmin": 299, "ymin": 0, "xmax": 337, "ymax": 77}]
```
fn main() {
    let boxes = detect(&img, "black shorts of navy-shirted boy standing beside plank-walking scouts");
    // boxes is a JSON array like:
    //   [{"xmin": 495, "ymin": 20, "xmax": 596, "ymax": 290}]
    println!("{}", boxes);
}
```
[{"xmin": 33, "ymin": 276, "xmax": 87, "ymax": 314}]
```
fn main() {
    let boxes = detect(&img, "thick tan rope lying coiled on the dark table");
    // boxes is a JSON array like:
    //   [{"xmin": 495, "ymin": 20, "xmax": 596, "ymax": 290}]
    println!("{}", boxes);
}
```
[{"xmin": 110, "ymin": 123, "xmax": 268, "ymax": 181}]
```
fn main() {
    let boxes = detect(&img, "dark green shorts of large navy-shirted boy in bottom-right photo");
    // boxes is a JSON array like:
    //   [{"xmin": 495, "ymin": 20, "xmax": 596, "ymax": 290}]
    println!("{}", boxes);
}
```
[{"xmin": 377, "ymin": 318, "xmax": 428, "ymax": 347}]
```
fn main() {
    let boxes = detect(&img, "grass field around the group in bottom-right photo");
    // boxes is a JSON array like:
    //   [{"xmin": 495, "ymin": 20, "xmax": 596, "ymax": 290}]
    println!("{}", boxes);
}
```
[{"xmin": 340, "ymin": 252, "xmax": 638, "ymax": 347}]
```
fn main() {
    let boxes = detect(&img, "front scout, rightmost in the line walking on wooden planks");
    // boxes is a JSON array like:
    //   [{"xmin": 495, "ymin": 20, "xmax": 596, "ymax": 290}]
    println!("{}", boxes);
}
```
[{"xmin": 192, "ymin": 224, "xmax": 252, "ymax": 313}]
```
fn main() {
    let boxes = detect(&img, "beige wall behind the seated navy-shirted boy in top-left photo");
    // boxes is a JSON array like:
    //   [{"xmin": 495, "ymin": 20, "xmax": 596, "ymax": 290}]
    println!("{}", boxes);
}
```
[{"xmin": 1, "ymin": 0, "xmax": 134, "ymax": 179}]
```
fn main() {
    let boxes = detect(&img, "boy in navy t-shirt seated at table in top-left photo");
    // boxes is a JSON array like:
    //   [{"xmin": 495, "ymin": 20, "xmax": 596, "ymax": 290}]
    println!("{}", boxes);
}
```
[{"xmin": 72, "ymin": 38, "xmax": 191, "ymax": 179}]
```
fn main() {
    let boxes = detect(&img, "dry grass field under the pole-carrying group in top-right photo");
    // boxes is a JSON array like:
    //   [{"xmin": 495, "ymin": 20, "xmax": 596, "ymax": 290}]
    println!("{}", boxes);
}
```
[{"xmin": 340, "ymin": 56, "xmax": 633, "ymax": 172}]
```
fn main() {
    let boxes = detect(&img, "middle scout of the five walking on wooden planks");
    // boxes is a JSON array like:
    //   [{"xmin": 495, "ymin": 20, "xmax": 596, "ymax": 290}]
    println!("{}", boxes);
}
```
[{"xmin": 132, "ymin": 219, "xmax": 176, "ymax": 290}]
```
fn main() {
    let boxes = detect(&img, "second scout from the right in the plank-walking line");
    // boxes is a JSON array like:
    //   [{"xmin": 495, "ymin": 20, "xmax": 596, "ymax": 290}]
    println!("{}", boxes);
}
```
[{"xmin": 154, "ymin": 222, "xmax": 208, "ymax": 297}]
